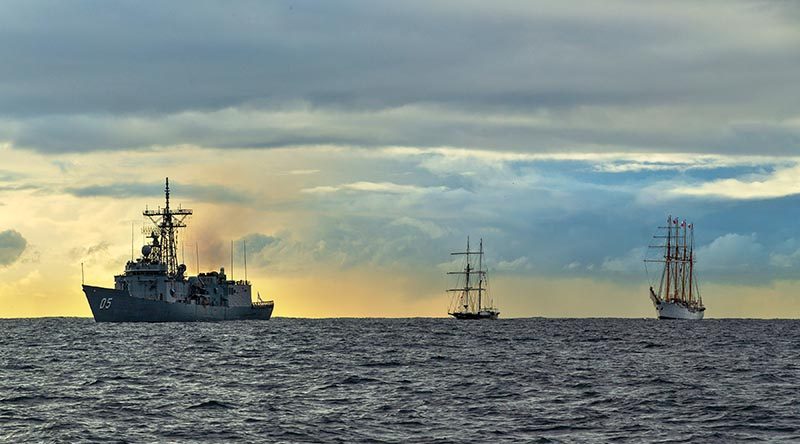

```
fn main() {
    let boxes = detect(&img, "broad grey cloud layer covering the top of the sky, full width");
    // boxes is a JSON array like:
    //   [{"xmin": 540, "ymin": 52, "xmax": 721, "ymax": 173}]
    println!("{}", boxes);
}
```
[{"xmin": 0, "ymin": 1, "xmax": 800, "ymax": 154}]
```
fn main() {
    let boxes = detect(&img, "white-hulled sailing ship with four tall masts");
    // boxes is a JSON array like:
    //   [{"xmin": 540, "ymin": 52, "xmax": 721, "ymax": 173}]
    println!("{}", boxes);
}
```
[{"xmin": 645, "ymin": 216, "xmax": 706, "ymax": 320}]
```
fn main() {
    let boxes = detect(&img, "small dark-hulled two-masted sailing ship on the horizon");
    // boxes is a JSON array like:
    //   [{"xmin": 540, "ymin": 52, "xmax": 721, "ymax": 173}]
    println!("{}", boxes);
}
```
[{"xmin": 447, "ymin": 237, "xmax": 500, "ymax": 319}]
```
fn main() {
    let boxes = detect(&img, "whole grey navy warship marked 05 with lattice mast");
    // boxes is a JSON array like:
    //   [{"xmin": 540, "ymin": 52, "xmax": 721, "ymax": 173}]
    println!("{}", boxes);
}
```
[{"xmin": 83, "ymin": 178, "xmax": 275, "ymax": 322}]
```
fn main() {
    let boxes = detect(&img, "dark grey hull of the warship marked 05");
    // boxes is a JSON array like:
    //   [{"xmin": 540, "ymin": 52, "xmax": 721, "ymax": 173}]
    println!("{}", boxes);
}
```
[{"xmin": 83, "ymin": 285, "xmax": 274, "ymax": 322}]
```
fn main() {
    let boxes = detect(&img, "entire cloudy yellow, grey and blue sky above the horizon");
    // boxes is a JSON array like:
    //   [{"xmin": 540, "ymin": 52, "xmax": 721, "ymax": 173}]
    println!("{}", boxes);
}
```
[{"xmin": 0, "ymin": 0, "xmax": 800, "ymax": 318}]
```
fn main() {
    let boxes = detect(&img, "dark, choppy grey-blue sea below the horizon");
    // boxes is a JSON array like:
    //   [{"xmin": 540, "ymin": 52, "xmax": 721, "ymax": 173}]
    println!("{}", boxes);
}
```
[{"xmin": 0, "ymin": 319, "xmax": 800, "ymax": 442}]
